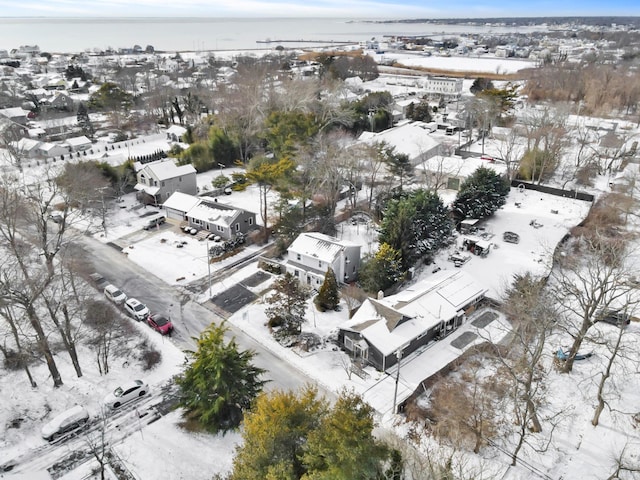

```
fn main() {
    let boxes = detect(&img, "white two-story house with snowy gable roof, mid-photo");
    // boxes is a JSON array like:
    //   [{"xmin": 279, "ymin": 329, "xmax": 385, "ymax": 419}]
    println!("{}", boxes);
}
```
[{"xmin": 285, "ymin": 232, "xmax": 360, "ymax": 289}]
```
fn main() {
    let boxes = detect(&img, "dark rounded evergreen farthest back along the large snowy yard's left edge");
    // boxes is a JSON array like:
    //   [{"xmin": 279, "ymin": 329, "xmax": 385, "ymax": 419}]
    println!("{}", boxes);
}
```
[{"xmin": 452, "ymin": 167, "xmax": 509, "ymax": 221}]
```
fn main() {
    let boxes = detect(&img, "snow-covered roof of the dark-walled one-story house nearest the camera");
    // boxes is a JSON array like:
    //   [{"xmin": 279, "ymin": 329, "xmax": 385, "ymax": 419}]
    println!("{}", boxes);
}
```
[{"xmin": 344, "ymin": 270, "xmax": 487, "ymax": 355}]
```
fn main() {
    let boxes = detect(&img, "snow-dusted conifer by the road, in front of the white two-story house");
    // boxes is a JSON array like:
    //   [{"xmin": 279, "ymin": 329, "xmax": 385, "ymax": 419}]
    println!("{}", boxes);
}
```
[{"xmin": 265, "ymin": 272, "xmax": 307, "ymax": 335}]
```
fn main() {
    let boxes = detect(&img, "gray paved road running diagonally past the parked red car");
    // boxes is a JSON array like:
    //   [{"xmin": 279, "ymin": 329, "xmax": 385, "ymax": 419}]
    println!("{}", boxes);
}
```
[{"xmin": 70, "ymin": 232, "xmax": 311, "ymax": 390}]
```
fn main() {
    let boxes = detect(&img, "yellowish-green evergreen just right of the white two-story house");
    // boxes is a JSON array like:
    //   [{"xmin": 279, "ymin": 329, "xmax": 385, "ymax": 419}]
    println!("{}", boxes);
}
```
[{"xmin": 358, "ymin": 243, "xmax": 404, "ymax": 293}]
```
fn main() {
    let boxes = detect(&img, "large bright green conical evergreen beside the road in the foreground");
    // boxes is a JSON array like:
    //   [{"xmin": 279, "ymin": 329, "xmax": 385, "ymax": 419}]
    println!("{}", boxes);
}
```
[{"xmin": 177, "ymin": 323, "xmax": 266, "ymax": 432}]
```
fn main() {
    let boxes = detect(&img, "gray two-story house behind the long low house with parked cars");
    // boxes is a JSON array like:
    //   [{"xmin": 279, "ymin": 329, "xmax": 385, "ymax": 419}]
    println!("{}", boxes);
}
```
[{"xmin": 134, "ymin": 158, "xmax": 198, "ymax": 205}]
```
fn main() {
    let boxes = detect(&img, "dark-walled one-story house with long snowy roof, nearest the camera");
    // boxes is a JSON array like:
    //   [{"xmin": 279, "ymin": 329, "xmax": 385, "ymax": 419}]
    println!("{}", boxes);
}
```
[{"xmin": 338, "ymin": 269, "xmax": 487, "ymax": 371}]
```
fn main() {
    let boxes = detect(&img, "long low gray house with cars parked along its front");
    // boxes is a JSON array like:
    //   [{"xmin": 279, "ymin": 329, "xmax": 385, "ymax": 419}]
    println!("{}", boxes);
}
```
[{"xmin": 162, "ymin": 192, "xmax": 256, "ymax": 240}]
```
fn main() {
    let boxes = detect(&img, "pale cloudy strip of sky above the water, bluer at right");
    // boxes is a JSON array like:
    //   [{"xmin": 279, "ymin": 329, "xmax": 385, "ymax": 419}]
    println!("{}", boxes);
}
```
[{"xmin": 0, "ymin": 0, "xmax": 640, "ymax": 19}]
